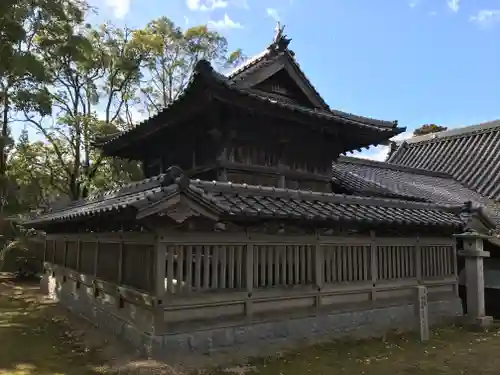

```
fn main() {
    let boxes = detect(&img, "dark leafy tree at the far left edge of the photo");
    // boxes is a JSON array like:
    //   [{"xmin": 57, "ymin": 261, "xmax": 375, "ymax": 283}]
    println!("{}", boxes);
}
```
[{"xmin": 0, "ymin": 0, "xmax": 87, "ymax": 212}]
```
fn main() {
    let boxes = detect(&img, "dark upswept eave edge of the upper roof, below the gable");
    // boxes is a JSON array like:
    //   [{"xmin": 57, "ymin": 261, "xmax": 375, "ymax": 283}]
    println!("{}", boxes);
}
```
[{"xmin": 95, "ymin": 60, "xmax": 405, "ymax": 156}]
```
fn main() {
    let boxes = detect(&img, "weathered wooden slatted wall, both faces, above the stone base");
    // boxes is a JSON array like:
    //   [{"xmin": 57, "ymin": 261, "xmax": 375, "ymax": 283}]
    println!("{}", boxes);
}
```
[{"xmin": 44, "ymin": 233, "xmax": 456, "ymax": 322}]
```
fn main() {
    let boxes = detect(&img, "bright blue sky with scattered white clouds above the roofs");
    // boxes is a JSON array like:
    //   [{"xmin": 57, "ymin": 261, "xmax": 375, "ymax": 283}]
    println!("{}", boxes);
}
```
[{"xmin": 87, "ymin": 0, "xmax": 500, "ymax": 159}]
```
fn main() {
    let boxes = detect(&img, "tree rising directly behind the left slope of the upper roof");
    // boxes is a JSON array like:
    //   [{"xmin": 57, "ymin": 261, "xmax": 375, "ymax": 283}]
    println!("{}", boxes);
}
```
[{"xmin": 134, "ymin": 17, "xmax": 244, "ymax": 115}]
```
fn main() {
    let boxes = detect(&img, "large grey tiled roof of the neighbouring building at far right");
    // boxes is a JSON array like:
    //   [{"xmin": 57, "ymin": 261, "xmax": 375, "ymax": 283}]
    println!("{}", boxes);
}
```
[{"xmin": 388, "ymin": 121, "xmax": 500, "ymax": 201}]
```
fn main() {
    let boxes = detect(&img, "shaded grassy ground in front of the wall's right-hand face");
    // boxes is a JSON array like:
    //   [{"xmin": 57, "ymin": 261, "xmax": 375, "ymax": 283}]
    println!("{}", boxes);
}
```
[{"xmin": 210, "ymin": 326, "xmax": 500, "ymax": 375}]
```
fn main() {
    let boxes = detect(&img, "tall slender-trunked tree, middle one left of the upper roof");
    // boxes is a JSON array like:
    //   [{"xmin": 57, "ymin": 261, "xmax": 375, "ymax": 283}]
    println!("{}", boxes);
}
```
[{"xmin": 24, "ymin": 24, "xmax": 142, "ymax": 200}]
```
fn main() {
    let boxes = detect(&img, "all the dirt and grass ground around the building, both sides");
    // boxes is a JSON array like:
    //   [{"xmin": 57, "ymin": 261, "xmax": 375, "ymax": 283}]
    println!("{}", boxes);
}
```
[{"xmin": 0, "ymin": 275, "xmax": 500, "ymax": 375}]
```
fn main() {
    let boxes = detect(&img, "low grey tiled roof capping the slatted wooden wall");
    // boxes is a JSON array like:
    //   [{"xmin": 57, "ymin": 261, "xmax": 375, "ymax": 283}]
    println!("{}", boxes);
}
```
[{"xmin": 25, "ymin": 169, "xmax": 462, "ymax": 228}]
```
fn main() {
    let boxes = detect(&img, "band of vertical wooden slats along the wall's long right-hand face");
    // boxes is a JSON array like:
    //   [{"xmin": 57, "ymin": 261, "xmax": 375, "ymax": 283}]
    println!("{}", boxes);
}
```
[{"xmin": 160, "ymin": 238, "xmax": 456, "ymax": 295}]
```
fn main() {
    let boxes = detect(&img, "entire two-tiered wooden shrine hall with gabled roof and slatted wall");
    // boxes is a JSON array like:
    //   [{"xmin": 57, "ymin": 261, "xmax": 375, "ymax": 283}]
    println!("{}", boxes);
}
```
[{"xmin": 24, "ymin": 28, "xmax": 495, "ymax": 358}]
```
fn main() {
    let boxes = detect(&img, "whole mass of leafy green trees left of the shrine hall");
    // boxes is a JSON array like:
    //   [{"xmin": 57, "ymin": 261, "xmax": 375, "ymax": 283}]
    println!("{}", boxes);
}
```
[{"xmin": 0, "ymin": 4, "xmax": 245, "ymax": 214}]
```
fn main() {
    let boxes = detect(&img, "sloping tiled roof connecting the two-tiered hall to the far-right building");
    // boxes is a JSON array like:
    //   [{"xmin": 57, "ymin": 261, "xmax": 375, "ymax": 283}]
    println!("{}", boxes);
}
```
[{"xmin": 333, "ymin": 157, "xmax": 500, "ymax": 224}]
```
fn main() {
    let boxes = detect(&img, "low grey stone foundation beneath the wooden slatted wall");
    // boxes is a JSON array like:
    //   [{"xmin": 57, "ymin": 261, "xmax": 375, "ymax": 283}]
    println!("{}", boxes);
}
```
[{"xmin": 42, "ymin": 275, "xmax": 462, "ymax": 359}]
